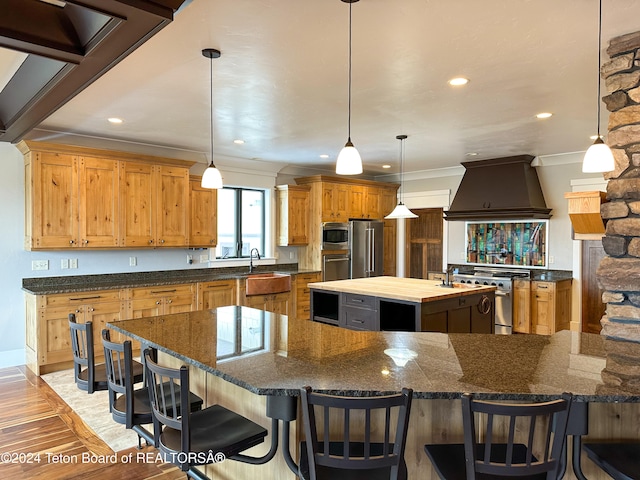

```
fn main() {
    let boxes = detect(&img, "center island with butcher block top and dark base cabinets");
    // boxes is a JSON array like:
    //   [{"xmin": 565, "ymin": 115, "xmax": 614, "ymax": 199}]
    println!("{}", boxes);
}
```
[{"xmin": 309, "ymin": 276, "xmax": 496, "ymax": 333}]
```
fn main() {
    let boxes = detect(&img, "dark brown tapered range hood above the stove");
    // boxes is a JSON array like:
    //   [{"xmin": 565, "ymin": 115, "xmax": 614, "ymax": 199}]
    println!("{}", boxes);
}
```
[{"xmin": 444, "ymin": 155, "xmax": 551, "ymax": 220}]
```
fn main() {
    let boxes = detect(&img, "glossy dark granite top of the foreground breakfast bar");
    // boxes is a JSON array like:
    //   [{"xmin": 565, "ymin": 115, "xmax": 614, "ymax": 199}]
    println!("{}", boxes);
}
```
[{"xmin": 109, "ymin": 307, "xmax": 640, "ymax": 402}]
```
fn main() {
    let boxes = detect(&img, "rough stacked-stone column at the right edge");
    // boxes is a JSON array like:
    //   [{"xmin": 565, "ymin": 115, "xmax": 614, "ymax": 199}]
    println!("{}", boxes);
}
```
[{"xmin": 596, "ymin": 32, "xmax": 640, "ymax": 342}]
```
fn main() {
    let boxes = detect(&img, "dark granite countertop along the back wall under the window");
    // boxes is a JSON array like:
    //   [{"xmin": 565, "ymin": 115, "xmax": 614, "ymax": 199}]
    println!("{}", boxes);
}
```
[{"xmin": 22, "ymin": 263, "xmax": 317, "ymax": 295}]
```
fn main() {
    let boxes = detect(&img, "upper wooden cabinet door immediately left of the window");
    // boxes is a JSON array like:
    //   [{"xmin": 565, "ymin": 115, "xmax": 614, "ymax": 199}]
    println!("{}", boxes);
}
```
[{"xmin": 189, "ymin": 178, "xmax": 218, "ymax": 248}]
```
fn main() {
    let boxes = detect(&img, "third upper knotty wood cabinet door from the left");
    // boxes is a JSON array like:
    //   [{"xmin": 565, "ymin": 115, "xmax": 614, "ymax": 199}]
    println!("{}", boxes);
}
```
[{"xmin": 120, "ymin": 162, "xmax": 155, "ymax": 247}]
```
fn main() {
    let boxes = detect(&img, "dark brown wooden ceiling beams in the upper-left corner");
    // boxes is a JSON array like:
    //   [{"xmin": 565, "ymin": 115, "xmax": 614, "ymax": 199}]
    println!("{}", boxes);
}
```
[{"xmin": 0, "ymin": 0, "xmax": 191, "ymax": 143}]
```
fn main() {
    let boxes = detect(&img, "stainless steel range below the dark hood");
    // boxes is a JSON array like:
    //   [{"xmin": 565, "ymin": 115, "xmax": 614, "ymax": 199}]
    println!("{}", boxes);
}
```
[{"xmin": 453, "ymin": 267, "xmax": 530, "ymax": 335}]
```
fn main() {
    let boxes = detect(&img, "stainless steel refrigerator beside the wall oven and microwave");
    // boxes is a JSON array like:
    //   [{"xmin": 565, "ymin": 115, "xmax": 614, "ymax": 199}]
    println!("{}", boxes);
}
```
[{"xmin": 349, "ymin": 220, "xmax": 384, "ymax": 278}]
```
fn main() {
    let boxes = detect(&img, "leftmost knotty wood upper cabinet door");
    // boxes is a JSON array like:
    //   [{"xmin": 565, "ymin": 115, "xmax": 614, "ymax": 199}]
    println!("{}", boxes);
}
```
[{"xmin": 31, "ymin": 152, "xmax": 78, "ymax": 248}]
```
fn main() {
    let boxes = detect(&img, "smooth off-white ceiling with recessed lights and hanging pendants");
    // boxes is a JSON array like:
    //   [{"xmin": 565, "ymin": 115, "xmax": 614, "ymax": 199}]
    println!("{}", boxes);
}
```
[{"xmin": 15, "ymin": 0, "xmax": 640, "ymax": 175}]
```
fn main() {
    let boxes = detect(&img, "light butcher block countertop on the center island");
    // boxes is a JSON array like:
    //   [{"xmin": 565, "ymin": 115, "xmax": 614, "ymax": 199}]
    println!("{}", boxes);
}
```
[{"xmin": 309, "ymin": 277, "xmax": 496, "ymax": 303}]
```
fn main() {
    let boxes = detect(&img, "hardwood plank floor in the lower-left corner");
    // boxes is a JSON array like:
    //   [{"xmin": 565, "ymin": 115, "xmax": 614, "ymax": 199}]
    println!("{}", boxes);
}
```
[{"xmin": 0, "ymin": 366, "xmax": 186, "ymax": 480}]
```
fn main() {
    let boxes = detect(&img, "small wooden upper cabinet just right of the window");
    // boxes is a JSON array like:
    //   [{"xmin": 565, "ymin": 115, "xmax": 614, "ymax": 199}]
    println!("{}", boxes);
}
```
[{"xmin": 276, "ymin": 185, "xmax": 311, "ymax": 247}]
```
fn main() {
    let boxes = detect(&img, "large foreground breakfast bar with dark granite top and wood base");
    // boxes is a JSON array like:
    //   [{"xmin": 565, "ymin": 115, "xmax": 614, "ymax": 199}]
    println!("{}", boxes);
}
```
[{"xmin": 109, "ymin": 307, "xmax": 640, "ymax": 480}]
